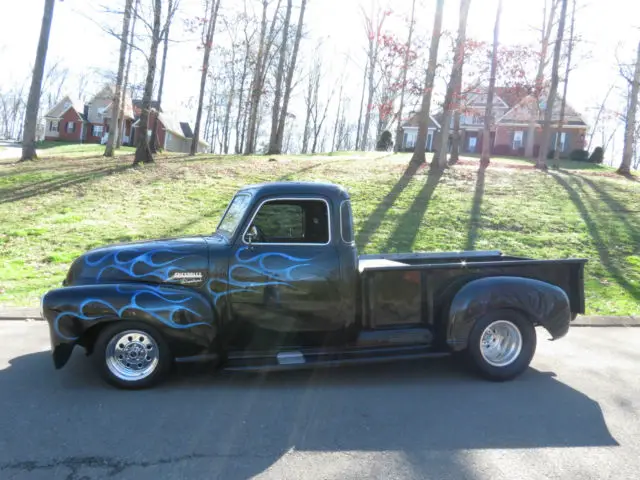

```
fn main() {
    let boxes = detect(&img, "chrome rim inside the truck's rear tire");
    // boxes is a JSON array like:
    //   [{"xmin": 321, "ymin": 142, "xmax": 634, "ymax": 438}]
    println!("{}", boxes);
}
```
[{"xmin": 480, "ymin": 320, "xmax": 522, "ymax": 367}]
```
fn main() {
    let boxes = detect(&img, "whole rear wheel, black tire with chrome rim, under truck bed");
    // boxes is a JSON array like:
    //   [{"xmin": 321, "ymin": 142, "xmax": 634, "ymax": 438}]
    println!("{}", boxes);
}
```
[{"xmin": 467, "ymin": 310, "xmax": 537, "ymax": 382}]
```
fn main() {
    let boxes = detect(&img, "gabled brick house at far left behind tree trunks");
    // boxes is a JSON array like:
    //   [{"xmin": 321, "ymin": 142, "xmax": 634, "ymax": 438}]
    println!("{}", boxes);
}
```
[{"xmin": 44, "ymin": 85, "xmax": 134, "ymax": 145}]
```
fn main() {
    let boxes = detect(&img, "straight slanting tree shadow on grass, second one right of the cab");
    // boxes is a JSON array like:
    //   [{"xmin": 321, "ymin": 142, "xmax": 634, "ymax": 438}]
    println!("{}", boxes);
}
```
[{"xmin": 384, "ymin": 168, "xmax": 444, "ymax": 252}]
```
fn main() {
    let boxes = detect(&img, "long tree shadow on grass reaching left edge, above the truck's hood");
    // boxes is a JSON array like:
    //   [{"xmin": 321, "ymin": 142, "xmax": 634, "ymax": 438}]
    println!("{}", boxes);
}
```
[{"xmin": 0, "ymin": 165, "xmax": 132, "ymax": 203}]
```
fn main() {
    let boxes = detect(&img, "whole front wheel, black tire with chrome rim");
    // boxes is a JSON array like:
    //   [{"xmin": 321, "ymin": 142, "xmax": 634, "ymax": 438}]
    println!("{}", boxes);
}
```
[{"xmin": 93, "ymin": 321, "xmax": 171, "ymax": 390}]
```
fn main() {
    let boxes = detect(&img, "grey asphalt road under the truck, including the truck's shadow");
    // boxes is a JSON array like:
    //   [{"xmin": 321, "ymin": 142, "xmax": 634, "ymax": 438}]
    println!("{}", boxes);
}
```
[{"xmin": 0, "ymin": 321, "xmax": 640, "ymax": 480}]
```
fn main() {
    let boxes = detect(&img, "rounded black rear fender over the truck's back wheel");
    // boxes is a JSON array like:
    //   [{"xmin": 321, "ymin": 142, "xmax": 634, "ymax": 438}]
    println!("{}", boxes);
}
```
[{"xmin": 447, "ymin": 277, "xmax": 571, "ymax": 350}]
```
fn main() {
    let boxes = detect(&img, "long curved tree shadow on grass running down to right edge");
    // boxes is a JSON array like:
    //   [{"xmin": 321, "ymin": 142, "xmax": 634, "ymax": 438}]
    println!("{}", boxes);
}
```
[{"xmin": 550, "ymin": 173, "xmax": 640, "ymax": 302}]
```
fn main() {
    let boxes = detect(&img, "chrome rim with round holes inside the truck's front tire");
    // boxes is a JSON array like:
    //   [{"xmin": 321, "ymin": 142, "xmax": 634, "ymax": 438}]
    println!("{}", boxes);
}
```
[{"xmin": 105, "ymin": 330, "xmax": 160, "ymax": 382}]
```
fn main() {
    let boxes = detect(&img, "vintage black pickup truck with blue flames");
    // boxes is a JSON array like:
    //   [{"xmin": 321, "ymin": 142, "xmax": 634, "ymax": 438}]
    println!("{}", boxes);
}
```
[{"xmin": 42, "ymin": 182, "xmax": 586, "ymax": 388}]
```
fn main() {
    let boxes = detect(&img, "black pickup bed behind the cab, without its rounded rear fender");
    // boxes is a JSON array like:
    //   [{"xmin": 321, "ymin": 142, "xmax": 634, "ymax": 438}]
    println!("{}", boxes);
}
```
[{"xmin": 358, "ymin": 251, "xmax": 586, "ymax": 329}]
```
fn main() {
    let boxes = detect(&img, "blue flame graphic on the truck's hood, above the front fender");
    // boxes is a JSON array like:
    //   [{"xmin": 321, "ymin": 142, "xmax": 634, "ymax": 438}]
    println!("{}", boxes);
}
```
[{"xmin": 84, "ymin": 244, "xmax": 203, "ymax": 281}]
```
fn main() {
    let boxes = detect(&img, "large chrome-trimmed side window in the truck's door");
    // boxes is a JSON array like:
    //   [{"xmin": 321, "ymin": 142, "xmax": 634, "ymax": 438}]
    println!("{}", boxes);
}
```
[{"xmin": 245, "ymin": 199, "xmax": 329, "ymax": 244}]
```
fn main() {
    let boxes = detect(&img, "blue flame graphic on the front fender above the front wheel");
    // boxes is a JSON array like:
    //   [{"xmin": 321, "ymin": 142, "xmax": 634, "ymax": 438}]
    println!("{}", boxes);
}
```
[{"xmin": 53, "ymin": 285, "xmax": 211, "ymax": 341}]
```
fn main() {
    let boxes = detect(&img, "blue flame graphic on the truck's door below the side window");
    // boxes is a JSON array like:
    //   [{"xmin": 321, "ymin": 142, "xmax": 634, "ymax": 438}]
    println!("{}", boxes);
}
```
[{"xmin": 207, "ymin": 247, "xmax": 315, "ymax": 304}]
